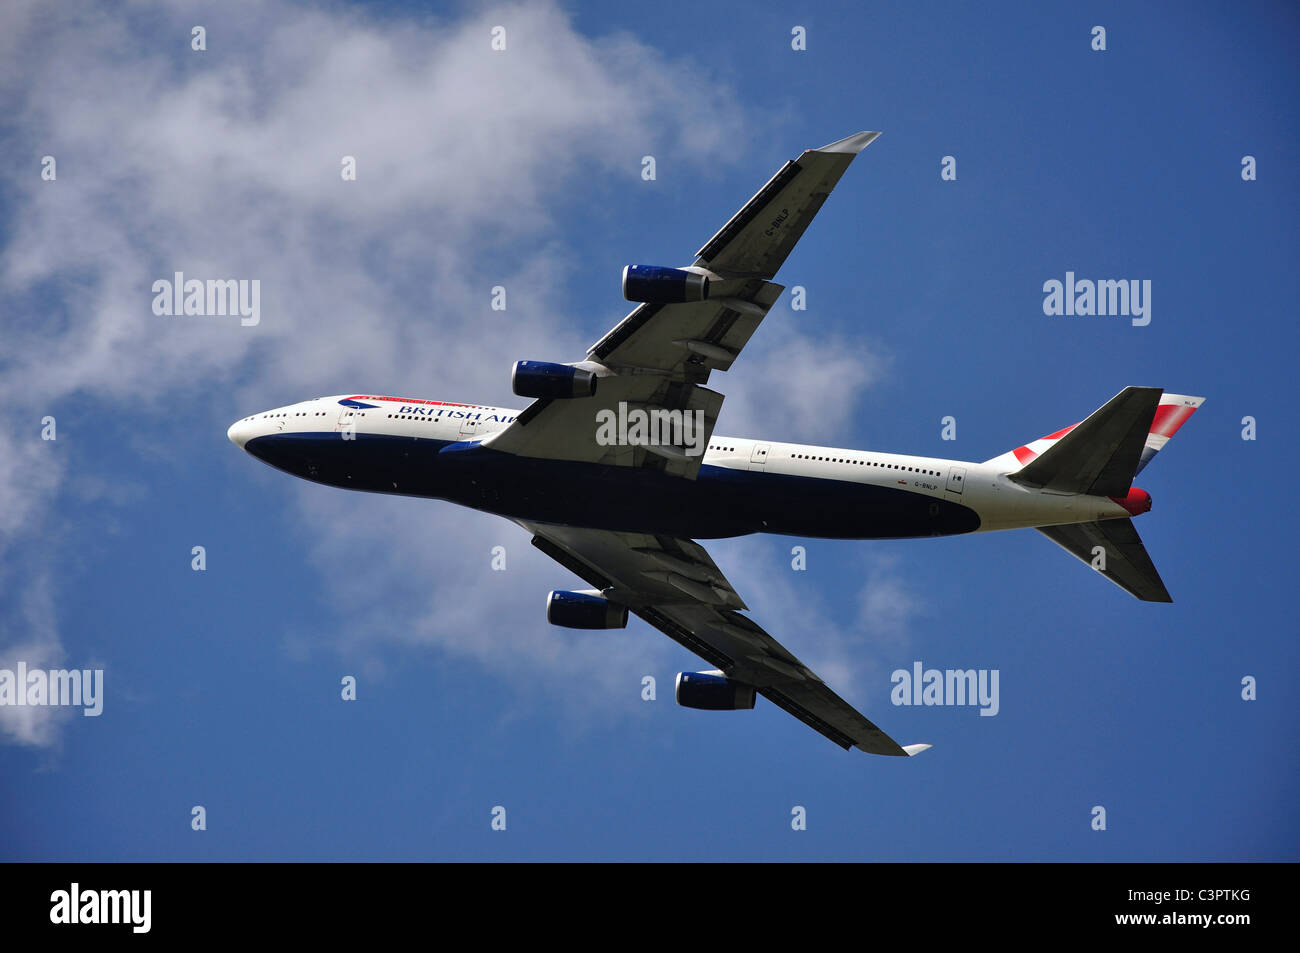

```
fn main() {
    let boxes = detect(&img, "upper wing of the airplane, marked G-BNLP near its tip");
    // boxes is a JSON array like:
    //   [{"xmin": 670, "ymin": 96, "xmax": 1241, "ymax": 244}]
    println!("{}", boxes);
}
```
[{"xmin": 482, "ymin": 133, "xmax": 880, "ymax": 480}]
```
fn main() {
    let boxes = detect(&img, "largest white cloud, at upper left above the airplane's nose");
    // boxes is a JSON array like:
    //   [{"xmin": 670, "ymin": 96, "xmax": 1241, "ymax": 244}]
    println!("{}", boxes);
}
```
[{"xmin": 0, "ymin": 4, "xmax": 742, "ymax": 399}]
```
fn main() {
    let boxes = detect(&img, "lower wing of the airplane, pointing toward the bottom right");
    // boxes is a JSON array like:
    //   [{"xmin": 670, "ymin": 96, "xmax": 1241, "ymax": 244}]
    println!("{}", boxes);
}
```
[{"xmin": 519, "ymin": 520, "xmax": 930, "ymax": 755}]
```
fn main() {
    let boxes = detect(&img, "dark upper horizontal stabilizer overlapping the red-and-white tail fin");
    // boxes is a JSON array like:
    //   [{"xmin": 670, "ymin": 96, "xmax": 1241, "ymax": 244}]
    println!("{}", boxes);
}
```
[{"xmin": 1011, "ymin": 387, "xmax": 1164, "ymax": 494}]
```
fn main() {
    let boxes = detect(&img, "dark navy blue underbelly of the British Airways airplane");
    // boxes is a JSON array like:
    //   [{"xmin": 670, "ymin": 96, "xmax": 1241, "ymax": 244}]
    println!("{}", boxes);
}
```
[{"xmin": 244, "ymin": 433, "xmax": 979, "ymax": 540}]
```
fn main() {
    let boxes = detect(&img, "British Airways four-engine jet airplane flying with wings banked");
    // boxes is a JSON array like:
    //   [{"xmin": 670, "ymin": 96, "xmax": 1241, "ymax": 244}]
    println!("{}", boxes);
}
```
[{"xmin": 228, "ymin": 133, "xmax": 1203, "ymax": 755}]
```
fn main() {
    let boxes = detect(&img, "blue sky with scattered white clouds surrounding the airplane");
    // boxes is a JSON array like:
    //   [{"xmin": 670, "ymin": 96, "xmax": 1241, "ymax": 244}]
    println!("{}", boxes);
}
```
[{"xmin": 0, "ymin": 3, "xmax": 1300, "ymax": 861}]
